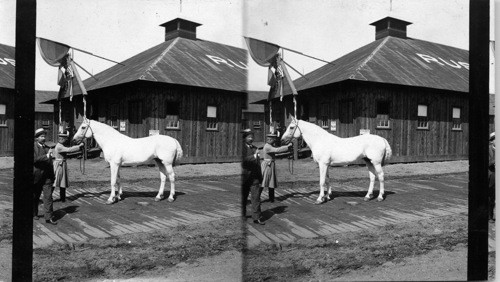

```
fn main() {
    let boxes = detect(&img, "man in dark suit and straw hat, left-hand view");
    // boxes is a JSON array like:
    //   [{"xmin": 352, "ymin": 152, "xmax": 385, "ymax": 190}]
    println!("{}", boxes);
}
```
[{"xmin": 33, "ymin": 128, "xmax": 57, "ymax": 225}]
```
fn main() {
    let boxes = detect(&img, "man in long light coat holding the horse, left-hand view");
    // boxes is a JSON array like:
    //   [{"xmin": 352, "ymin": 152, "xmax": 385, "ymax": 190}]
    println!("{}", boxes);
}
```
[{"xmin": 54, "ymin": 131, "xmax": 84, "ymax": 203}]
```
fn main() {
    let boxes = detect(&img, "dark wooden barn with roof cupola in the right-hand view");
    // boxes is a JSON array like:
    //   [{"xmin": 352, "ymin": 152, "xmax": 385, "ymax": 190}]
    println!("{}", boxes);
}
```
[{"xmin": 264, "ymin": 17, "xmax": 482, "ymax": 162}]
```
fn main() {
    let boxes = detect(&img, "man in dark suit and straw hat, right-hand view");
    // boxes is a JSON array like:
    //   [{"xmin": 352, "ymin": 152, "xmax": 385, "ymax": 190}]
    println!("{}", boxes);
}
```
[{"xmin": 241, "ymin": 129, "xmax": 264, "ymax": 225}]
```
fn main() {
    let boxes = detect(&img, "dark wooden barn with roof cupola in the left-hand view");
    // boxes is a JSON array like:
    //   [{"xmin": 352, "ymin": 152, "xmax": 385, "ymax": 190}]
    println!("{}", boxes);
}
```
[{"xmin": 48, "ymin": 18, "xmax": 248, "ymax": 163}]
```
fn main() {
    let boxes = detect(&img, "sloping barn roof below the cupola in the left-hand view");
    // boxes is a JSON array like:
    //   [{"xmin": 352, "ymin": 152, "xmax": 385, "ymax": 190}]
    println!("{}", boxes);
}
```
[{"xmin": 78, "ymin": 37, "xmax": 247, "ymax": 92}]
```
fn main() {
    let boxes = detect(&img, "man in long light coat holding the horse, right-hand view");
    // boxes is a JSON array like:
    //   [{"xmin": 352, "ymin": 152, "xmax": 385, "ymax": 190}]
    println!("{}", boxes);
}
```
[{"xmin": 260, "ymin": 134, "xmax": 293, "ymax": 203}]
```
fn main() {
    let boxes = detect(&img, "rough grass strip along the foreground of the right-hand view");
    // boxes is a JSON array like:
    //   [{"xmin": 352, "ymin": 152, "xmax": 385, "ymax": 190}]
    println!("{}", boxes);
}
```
[{"xmin": 243, "ymin": 215, "xmax": 467, "ymax": 281}]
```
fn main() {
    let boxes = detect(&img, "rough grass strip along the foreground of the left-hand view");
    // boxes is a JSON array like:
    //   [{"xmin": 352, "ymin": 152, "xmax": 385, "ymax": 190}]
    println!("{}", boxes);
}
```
[{"xmin": 33, "ymin": 218, "xmax": 245, "ymax": 281}]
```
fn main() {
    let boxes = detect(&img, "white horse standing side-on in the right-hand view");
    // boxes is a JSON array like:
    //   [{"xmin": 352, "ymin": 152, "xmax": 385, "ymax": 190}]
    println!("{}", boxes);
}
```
[{"xmin": 281, "ymin": 117, "xmax": 392, "ymax": 204}]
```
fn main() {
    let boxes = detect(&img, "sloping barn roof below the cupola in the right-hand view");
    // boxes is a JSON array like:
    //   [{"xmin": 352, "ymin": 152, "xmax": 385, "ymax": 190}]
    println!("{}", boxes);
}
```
[{"xmin": 278, "ymin": 36, "xmax": 469, "ymax": 98}]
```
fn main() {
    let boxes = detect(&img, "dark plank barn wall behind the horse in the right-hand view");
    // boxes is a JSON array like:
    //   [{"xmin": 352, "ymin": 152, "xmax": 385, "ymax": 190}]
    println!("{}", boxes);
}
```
[{"xmin": 273, "ymin": 82, "xmax": 469, "ymax": 162}]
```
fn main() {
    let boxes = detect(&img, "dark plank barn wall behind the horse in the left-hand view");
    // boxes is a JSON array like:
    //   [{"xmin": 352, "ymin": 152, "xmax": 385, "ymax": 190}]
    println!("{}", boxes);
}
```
[{"xmin": 93, "ymin": 83, "xmax": 245, "ymax": 163}]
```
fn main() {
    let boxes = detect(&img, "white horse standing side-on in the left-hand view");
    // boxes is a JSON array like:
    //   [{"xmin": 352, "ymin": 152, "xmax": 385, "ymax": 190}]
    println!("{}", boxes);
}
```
[{"xmin": 73, "ymin": 119, "xmax": 182, "ymax": 204}]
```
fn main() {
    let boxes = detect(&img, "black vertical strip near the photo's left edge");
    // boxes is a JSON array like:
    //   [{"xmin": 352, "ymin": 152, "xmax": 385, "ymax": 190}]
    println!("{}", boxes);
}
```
[{"xmin": 12, "ymin": 0, "xmax": 36, "ymax": 281}]
